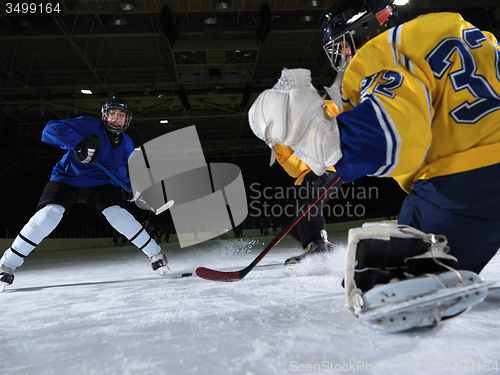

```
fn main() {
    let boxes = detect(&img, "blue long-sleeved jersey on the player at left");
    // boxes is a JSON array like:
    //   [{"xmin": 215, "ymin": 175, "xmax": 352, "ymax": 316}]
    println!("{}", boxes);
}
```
[{"xmin": 42, "ymin": 117, "xmax": 134, "ymax": 187}]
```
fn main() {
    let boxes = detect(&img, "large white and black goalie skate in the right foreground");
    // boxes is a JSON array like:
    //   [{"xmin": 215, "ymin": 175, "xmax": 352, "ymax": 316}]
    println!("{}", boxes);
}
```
[{"xmin": 344, "ymin": 222, "xmax": 491, "ymax": 333}]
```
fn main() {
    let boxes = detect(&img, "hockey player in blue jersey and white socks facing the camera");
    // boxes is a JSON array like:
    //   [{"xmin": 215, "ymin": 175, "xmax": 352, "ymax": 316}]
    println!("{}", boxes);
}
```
[{"xmin": 0, "ymin": 97, "xmax": 170, "ymax": 291}]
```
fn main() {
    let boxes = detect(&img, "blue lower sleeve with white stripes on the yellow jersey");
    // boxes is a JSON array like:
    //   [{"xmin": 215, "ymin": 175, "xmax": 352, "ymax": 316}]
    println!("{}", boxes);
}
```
[{"xmin": 335, "ymin": 98, "xmax": 400, "ymax": 183}]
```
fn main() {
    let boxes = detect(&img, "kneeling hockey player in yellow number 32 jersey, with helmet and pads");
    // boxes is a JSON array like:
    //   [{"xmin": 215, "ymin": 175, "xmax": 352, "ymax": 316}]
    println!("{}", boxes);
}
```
[{"xmin": 249, "ymin": 0, "xmax": 500, "ymax": 332}]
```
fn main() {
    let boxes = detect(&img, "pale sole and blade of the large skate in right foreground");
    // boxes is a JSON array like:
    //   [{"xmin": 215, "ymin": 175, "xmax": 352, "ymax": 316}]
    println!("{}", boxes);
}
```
[{"xmin": 355, "ymin": 271, "xmax": 493, "ymax": 333}]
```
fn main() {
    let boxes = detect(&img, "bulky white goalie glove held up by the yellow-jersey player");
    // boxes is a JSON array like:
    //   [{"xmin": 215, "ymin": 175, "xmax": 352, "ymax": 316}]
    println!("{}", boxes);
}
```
[{"xmin": 248, "ymin": 68, "xmax": 342, "ymax": 175}]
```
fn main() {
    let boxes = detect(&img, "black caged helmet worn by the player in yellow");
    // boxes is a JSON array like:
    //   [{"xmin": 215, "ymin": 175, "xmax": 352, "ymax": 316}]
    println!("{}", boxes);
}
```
[{"xmin": 323, "ymin": 0, "xmax": 396, "ymax": 71}]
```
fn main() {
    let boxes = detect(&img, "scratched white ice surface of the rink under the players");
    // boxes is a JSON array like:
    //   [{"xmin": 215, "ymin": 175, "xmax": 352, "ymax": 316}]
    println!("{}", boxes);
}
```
[{"xmin": 0, "ymin": 233, "xmax": 500, "ymax": 375}]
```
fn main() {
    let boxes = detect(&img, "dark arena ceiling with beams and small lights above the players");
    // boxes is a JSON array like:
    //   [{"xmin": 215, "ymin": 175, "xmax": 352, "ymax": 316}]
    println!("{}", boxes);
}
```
[{"xmin": 0, "ymin": 0, "xmax": 500, "ymax": 191}]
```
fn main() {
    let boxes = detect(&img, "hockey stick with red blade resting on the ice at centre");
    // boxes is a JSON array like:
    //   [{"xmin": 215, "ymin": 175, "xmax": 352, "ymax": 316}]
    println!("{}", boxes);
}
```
[{"xmin": 196, "ymin": 177, "xmax": 342, "ymax": 281}]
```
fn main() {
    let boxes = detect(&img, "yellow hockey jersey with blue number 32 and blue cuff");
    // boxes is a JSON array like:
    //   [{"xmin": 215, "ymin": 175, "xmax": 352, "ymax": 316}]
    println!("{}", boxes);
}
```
[{"xmin": 335, "ymin": 13, "xmax": 500, "ymax": 191}]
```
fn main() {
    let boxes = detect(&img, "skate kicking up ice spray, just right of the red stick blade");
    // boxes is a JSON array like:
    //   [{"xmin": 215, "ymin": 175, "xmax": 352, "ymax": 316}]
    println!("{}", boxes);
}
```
[{"xmin": 284, "ymin": 230, "xmax": 335, "ymax": 275}]
